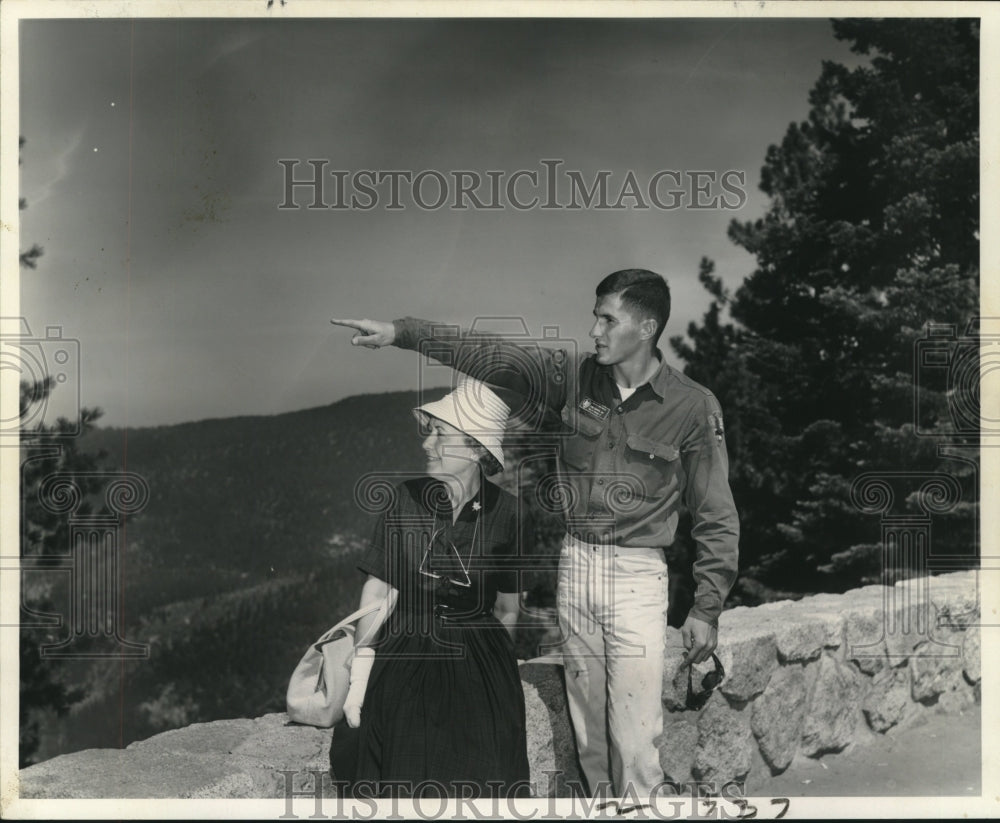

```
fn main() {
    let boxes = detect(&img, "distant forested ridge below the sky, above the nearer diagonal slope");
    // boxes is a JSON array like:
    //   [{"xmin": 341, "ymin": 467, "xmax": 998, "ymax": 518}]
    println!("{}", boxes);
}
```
[{"xmin": 82, "ymin": 390, "xmax": 443, "ymax": 616}]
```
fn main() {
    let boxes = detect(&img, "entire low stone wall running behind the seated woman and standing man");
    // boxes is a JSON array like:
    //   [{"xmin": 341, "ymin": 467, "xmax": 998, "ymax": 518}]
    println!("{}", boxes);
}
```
[{"xmin": 20, "ymin": 572, "xmax": 980, "ymax": 798}]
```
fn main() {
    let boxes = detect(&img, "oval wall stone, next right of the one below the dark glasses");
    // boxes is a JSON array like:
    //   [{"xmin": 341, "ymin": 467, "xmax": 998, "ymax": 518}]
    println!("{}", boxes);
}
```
[{"xmin": 750, "ymin": 666, "xmax": 808, "ymax": 773}]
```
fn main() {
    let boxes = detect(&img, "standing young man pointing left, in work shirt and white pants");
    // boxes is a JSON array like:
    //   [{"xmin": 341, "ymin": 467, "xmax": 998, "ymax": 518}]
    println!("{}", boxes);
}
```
[{"xmin": 332, "ymin": 269, "xmax": 739, "ymax": 797}]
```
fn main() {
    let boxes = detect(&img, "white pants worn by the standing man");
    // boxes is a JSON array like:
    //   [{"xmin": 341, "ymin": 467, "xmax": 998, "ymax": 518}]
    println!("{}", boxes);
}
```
[{"xmin": 557, "ymin": 535, "xmax": 668, "ymax": 798}]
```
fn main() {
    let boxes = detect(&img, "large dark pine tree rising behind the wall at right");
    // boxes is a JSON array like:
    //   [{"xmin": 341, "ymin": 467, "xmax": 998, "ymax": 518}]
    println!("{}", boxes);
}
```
[{"xmin": 671, "ymin": 19, "xmax": 979, "ymax": 600}]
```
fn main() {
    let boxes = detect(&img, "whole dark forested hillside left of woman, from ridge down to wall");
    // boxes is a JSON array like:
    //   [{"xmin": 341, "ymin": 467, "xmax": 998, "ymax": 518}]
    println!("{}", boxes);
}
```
[{"xmin": 35, "ymin": 389, "xmax": 444, "ymax": 759}]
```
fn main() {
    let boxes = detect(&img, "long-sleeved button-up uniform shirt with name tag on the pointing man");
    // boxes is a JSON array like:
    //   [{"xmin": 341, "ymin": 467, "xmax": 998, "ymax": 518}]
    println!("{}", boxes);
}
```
[{"xmin": 394, "ymin": 318, "xmax": 739, "ymax": 625}]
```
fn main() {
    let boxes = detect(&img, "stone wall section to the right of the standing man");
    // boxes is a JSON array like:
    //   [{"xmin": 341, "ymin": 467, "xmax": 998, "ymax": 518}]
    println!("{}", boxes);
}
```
[{"xmin": 660, "ymin": 572, "xmax": 980, "ymax": 793}]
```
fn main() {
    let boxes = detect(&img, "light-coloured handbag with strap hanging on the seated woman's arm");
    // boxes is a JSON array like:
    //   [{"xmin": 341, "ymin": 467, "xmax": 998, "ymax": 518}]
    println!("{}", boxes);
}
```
[{"xmin": 285, "ymin": 599, "xmax": 394, "ymax": 729}]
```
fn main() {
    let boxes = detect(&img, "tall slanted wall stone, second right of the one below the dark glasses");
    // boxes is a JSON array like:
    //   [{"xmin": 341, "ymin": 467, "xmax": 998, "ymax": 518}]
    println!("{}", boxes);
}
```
[{"xmin": 801, "ymin": 655, "xmax": 861, "ymax": 757}]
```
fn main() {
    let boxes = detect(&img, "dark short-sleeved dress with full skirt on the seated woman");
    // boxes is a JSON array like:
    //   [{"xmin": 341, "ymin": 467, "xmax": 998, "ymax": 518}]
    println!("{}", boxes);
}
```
[{"xmin": 330, "ymin": 477, "xmax": 529, "ymax": 797}]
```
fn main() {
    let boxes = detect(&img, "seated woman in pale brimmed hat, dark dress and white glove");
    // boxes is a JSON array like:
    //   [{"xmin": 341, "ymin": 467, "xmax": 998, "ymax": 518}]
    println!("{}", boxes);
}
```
[{"xmin": 330, "ymin": 379, "xmax": 529, "ymax": 797}]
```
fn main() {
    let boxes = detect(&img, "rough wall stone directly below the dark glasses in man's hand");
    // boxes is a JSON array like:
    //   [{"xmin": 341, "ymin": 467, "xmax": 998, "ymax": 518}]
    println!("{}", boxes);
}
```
[{"xmin": 691, "ymin": 695, "xmax": 755, "ymax": 786}]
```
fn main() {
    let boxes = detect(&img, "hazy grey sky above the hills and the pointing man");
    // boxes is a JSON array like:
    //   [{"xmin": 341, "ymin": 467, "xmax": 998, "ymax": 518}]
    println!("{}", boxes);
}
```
[{"xmin": 19, "ymin": 18, "xmax": 860, "ymax": 427}]
